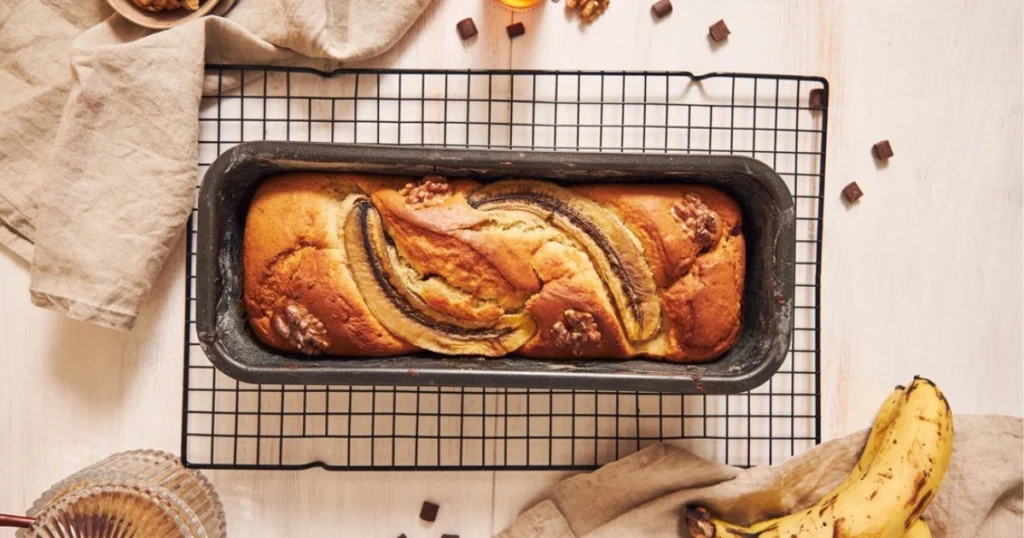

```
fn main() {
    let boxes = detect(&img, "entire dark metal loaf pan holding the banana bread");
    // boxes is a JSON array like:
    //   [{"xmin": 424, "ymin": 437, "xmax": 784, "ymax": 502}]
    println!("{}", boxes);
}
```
[{"xmin": 196, "ymin": 142, "xmax": 796, "ymax": 394}]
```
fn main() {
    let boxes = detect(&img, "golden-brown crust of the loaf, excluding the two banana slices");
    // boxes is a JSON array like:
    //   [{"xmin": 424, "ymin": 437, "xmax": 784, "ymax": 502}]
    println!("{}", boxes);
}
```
[{"xmin": 243, "ymin": 173, "xmax": 745, "ymax": 362}]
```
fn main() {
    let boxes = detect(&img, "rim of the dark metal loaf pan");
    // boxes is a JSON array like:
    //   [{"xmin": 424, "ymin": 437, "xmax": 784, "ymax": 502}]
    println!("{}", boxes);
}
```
[{"xmin": 196, "ymin": 141, "xmax": 796, "ymax": 394}]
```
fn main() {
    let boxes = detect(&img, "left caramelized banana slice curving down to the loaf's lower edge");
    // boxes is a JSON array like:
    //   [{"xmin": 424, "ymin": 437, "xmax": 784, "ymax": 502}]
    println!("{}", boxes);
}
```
[{"xmin": 344, "ymin": 200, "xmax": 537, "ymax": 357}]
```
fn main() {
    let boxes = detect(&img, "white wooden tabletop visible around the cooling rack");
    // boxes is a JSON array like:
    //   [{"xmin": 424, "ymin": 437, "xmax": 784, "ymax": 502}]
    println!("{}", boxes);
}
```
[{"xmin": 0, "ymin": 0, "xmax": 1024, "ymax": 538}]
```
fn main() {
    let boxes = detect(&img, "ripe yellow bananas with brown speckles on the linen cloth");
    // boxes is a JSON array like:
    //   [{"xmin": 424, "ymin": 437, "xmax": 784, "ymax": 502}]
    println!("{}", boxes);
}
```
[{"xmin": 686, "ymin": 378, "xmax": 953, "ymax": 538}]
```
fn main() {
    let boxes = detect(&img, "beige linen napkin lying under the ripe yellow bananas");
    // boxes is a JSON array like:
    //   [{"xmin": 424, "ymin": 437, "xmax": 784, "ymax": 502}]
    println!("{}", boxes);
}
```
[{"xmin": 498, "ymin": 416, "xmax": 1024, "ymax": 538}]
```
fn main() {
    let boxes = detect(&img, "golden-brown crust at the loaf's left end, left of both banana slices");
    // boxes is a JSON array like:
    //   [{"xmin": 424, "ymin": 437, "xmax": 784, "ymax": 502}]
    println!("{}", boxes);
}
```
[{"xmin": 243, "ymin": 173, "xmax": 416, "ymax": 357}]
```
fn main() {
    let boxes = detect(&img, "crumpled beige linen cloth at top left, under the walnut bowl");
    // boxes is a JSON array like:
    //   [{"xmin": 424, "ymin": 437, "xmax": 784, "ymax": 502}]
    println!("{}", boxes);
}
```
[{"xmin": 0, "ymin": 0, "xmax": 430, "ymax": 329}]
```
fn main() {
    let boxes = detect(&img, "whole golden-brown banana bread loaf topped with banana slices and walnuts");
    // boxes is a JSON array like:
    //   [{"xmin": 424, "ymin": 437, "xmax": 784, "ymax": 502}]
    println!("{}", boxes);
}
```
[{"xmin": 243, "ymin": 172, "xmax": 745, "ymax": 362}]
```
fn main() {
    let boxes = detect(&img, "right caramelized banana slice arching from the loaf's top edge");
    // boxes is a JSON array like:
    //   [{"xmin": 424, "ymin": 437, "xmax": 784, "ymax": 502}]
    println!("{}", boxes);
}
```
[{"xmin": 467, "ymin": 179, "xmax": 662, "ymax": 341}]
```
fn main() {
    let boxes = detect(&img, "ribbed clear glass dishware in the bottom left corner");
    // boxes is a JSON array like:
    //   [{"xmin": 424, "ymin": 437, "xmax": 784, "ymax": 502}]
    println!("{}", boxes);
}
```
[{"xmin": 17, "ymin": 450, "xmax": 227, "ymax": 538}]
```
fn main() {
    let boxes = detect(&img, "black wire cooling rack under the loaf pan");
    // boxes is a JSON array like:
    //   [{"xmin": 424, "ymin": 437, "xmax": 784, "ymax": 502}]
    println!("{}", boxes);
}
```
[{"xmin": 181, "ymin": 66, "xmax": 828, "ymax": 469}]
